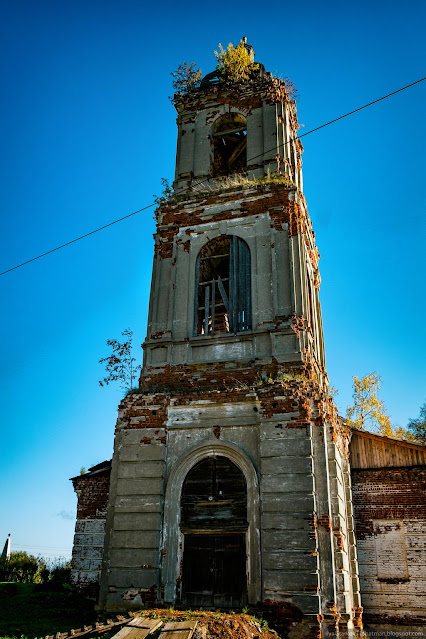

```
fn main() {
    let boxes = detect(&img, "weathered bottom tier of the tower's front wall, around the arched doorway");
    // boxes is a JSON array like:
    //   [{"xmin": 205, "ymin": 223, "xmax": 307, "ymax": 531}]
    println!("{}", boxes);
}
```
[{"xmin": 92, "ymin": 358, "xmax": 360, "ymax": 632}]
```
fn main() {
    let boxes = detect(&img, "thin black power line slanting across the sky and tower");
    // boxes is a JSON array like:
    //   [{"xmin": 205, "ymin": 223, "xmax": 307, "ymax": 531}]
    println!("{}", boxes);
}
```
[{"xmin": 0, "ymin": 78, "xmax": 426, "ymax": 275}]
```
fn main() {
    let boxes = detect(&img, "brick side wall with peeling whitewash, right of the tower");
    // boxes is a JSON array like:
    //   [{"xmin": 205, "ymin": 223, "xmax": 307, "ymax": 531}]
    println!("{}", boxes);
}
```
[{"xmin": 352, "ymin": 466, "xmax": 426, "ymax": 625}]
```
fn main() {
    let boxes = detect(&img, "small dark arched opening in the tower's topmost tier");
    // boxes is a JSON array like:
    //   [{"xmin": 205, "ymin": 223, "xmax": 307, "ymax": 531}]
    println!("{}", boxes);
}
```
[{"xmin": 213, "ymin": 113, "xmax": 247, "ymax": 177}]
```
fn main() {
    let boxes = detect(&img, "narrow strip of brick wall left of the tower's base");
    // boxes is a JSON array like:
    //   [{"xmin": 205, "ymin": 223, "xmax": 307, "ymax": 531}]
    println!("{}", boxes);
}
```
[{"xmin": 71, "ymin": 462, "xmax": 111, "ymax": 598}]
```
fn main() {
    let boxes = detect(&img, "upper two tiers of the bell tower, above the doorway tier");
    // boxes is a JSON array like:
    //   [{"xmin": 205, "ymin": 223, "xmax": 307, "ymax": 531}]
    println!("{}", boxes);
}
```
[{"xmin": 142, "ymin": 58, "xmax": 325, "ymax": 381}]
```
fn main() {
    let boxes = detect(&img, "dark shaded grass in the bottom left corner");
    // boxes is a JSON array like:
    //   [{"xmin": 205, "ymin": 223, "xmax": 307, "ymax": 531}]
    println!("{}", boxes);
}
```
[{"xmin": 0, "ymin": 582, "xmax": 96, "ymax": 639}]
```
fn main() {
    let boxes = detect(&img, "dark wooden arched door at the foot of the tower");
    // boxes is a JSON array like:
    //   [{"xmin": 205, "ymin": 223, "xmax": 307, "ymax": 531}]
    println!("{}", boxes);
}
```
[{"xmin": 180, "ymin": 455, "xmax": 248, "ymax": 608}]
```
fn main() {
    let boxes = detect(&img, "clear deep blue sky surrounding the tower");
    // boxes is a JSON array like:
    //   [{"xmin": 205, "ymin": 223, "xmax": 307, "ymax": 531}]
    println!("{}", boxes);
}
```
[{"xmin": 0, "ymin": 0, "xmax": 426, "ymax": 556}]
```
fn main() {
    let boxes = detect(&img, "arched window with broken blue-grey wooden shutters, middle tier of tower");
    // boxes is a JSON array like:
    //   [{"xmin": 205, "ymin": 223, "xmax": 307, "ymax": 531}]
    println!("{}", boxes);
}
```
[{"xmin": 194, "ymin": 235, "xmax": 251, "ymax": 335}]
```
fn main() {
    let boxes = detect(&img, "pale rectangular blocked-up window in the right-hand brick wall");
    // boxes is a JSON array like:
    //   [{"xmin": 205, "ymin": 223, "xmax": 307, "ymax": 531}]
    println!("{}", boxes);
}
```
[{"xmin": 373, "ymin": 519, "xmax": 408, "ymax": 581}]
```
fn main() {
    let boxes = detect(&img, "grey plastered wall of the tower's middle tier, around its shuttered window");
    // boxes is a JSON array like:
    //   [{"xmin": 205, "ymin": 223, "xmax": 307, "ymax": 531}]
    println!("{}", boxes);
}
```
[{"xmin": 144, "ymin": 195, "xmax": 324, "ymax": 380}]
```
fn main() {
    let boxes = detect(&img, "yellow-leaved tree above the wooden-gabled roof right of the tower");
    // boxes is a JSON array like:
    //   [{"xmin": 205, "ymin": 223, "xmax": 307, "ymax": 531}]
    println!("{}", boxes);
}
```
[{"xmin": 346, "ymin": 373, "xmax": 396, "ymax": 437}]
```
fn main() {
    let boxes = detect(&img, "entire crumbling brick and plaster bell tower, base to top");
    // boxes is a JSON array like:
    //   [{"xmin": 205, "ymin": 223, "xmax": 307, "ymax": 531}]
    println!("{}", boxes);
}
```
[{"xmin": 99, "ymin": 45, "xmax": 361, "ymax": 633}]
